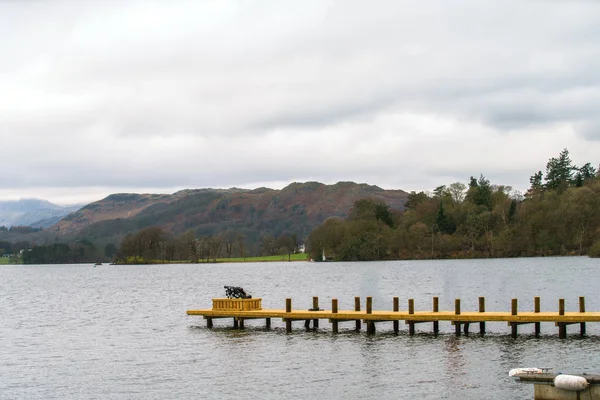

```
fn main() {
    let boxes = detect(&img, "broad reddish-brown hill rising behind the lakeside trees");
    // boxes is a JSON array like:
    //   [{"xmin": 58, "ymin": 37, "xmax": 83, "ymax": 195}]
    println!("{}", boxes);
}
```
[{"xmin": 52, "ymin": 182, "xmax": 408, "ymax": 250}]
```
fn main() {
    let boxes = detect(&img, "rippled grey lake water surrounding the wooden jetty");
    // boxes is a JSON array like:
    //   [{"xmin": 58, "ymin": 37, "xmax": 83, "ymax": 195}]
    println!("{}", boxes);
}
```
[{"xmin": 0, "ymin": 257, "xmax": 600, "ymax": 400}]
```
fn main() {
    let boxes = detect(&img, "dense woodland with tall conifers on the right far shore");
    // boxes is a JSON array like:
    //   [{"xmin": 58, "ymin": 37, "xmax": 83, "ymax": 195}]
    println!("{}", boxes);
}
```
[{"xmin": 307, "ymin": 149, "xmax": 600, "ymax": 261}]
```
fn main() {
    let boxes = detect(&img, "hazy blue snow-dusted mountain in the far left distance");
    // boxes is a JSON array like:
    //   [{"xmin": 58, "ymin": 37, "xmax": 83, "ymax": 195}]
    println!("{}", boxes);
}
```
[{"xmin": 0, "ymin": 199, "xmax": 82, "ymax": 228}]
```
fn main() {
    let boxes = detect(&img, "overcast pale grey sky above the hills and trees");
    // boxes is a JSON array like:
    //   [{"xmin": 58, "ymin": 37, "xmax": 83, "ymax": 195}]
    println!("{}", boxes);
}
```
[{"xmin": 0, "ymin": 0, "xmax": 600, "ymax": 204}]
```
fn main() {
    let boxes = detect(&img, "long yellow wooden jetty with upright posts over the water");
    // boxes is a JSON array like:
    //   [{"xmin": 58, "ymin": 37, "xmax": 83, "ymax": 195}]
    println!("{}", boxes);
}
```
[{"xmin": 187, "ymin": 297, "xmax": 600, "ymax": 338}]
